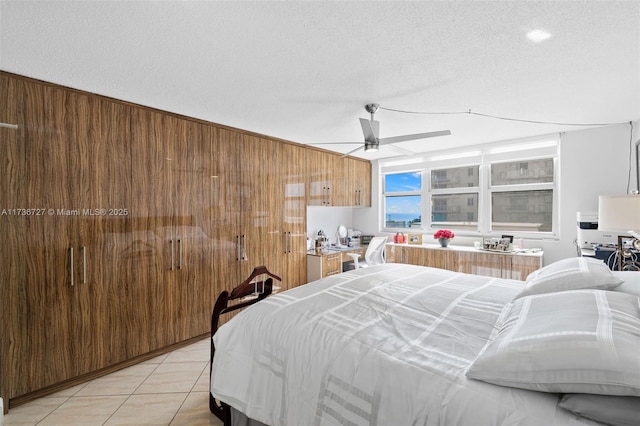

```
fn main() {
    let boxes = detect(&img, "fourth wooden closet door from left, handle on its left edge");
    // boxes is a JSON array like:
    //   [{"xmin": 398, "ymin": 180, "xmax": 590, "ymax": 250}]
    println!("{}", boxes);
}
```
[{"xmin": 172, "ymin": 120, "xmax": 221, "ymax": 341}]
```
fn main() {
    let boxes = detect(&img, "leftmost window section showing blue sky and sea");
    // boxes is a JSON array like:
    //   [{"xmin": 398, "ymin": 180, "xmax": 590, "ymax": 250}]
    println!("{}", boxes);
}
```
[{"xmin": 384, "ymin": 172, "xmax": 422, "ymax": 229}]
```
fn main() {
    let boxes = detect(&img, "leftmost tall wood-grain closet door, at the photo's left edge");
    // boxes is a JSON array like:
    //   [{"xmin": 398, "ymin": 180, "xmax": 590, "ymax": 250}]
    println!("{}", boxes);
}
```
[{"xmin": 0, "ymin": 75, "xmax": 75, "ymax": 398}]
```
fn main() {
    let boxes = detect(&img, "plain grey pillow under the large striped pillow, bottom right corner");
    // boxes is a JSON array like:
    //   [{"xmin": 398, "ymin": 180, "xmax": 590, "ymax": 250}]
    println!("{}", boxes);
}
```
[{"xmin": 558, "ymin": 393, "xmax": 640, "ymax": 426}]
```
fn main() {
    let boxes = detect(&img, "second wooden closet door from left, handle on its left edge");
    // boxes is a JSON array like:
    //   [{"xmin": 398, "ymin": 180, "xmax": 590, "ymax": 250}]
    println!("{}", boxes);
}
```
[{"xmin": 69, "ymin": 94, "xmax": 131, "ymax": 374}]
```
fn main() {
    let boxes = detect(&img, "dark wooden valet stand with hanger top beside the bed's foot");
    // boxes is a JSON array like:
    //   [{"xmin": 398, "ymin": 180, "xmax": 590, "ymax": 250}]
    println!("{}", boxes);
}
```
[{"xmin": 209, "ymin": 266, "xmax": 282, "ymax": 425}]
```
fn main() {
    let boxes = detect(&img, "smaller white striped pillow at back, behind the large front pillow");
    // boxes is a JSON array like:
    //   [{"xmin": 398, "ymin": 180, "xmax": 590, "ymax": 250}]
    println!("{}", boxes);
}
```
[{"xmin": 516, "ymin": 257, "xmax": 622, "ymax": 299}]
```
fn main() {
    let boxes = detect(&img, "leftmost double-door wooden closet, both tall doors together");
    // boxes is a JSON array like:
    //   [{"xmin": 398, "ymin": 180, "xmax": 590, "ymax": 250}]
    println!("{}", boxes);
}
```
[{"xmin": 0, "ymin": 74, "xmax": 131, "ymax": 398}]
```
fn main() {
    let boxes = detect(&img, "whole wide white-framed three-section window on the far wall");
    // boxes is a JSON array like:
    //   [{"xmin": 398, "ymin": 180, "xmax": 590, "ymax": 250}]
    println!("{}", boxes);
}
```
[{"xmin": 379, "ymin": 135, "xmax": 560, "ymax": 238}]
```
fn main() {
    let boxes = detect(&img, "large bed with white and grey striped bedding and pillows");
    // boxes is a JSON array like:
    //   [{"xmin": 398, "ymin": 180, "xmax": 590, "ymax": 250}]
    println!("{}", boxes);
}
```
[{"xmin": 210, "ymin": 258, "xmax": 640, "ymax": 426}]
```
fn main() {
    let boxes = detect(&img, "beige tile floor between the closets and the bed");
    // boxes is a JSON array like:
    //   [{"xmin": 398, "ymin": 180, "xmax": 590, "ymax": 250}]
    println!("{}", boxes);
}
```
[{"xmin": 4, "ymin": 339, "xmax": 222, "ymax": 426}]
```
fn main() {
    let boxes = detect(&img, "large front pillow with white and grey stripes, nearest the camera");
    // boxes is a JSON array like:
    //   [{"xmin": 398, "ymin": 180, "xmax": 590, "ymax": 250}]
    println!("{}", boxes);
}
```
[{"xmin": 466, "ymin": 290, "xmax": 640, "ymax": 396}]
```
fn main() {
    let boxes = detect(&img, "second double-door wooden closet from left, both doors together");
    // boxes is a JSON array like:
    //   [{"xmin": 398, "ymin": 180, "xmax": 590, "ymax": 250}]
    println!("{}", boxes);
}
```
[{"xmin": 131, "ymin": 108, "xmax": 220, "ymax": 356}]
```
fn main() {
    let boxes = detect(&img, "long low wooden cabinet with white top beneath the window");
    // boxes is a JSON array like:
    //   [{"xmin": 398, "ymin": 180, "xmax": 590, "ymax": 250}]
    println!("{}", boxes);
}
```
[{"xmin": 386, "ymin": 244, "xmax": 543, "ymax": 281}]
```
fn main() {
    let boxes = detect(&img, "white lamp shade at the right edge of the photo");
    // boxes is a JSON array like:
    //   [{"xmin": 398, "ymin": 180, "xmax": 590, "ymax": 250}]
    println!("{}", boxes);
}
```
[{"xmin": 598, "ymin": 194, "xmax": 640, "ymax": 233}]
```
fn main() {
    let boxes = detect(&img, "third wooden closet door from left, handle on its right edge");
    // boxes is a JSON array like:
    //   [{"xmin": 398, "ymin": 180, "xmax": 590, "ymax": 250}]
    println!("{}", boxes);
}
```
[{"xmin": 129, "ymin": 108, "xmax": 178, "ymax": 356}]
